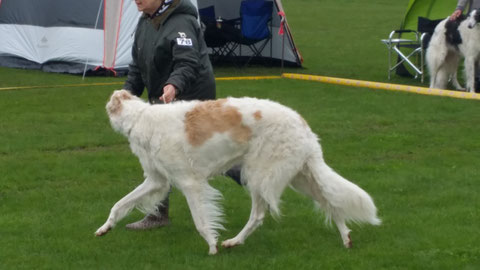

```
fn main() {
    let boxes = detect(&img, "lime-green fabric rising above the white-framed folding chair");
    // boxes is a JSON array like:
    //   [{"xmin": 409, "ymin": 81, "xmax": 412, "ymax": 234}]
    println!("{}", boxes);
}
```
[{"xmin": 401, "ymin": 0, "xmax": 457, "ymax": 30}]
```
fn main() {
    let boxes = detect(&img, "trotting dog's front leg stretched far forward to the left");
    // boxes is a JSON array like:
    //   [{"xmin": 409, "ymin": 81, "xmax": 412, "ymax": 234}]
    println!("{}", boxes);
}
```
[{"xmin": 95, "ymin": 178, "xmax": 168, "ymax": 236}]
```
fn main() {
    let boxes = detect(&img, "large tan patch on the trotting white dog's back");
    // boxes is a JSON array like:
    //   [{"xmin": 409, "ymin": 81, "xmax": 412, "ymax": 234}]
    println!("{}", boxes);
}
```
[{"xmin": 185, "ymin": 99, "xmax": 252, "ymax": 146}]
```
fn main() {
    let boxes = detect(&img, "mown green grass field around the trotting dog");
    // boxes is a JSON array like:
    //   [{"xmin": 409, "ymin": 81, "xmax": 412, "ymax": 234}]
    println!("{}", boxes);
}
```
[{"xmin": 0, "ymin": 0, "xmax": 480, "ymax": 270}]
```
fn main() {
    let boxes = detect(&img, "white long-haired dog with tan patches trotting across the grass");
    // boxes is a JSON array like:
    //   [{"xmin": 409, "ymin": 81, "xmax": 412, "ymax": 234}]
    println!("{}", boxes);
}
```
[{"xmin": 95, "ymin": 90, "xmax": 380, "ymax": 254}]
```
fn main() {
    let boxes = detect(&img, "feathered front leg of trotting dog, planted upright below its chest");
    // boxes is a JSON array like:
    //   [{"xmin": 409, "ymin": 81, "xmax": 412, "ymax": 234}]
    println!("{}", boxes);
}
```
[{"xmin": 179, "ymin": 181, "xmax": 224, "ymax": 255}]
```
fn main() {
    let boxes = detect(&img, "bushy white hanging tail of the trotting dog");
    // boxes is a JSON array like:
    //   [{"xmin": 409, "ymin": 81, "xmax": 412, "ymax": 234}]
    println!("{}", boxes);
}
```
[{"xmin": 307, "ymin": 157, "xmax": 381, "ymax": 226}]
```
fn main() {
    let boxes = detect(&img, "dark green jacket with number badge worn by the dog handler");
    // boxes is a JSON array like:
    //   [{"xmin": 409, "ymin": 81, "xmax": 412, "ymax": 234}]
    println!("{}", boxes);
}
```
[{"xmin": 124, "ymin": 0, "xmax": 216, "ymax": 103}]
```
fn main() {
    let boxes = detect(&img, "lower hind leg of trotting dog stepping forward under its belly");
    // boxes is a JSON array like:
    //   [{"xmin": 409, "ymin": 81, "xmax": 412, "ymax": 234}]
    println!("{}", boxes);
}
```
[{"xmin": 222, "ymin": 192, "xmax": 267, "ymax": 248}]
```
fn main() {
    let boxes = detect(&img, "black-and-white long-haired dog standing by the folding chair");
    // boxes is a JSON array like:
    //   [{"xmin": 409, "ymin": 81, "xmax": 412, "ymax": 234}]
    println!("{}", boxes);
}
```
[{"xmin": 426, "ymin": 10, "xmax": 480, "ymax": 92}]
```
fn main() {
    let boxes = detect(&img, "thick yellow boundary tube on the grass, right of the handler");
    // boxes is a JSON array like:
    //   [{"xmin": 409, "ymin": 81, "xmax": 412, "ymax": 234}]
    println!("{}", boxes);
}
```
[{"xmin": 282, "ymin": 73, "xmax": 480, "ymax": 100}]
